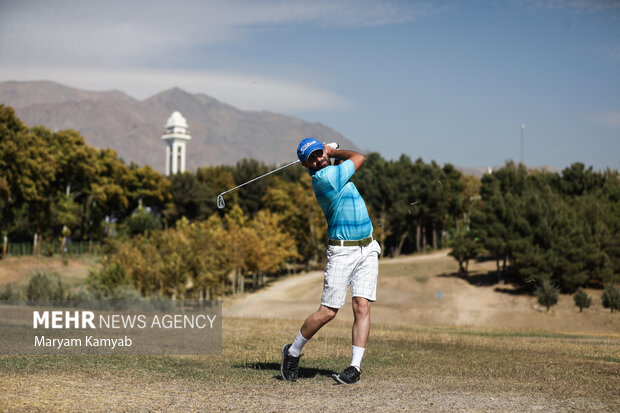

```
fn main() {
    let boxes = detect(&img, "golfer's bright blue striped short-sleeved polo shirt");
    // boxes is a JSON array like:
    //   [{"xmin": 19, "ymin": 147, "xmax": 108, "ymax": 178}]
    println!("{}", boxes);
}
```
[{"xmin": 310, "ymin": 160, "xmax": 372, "ymax": 240}]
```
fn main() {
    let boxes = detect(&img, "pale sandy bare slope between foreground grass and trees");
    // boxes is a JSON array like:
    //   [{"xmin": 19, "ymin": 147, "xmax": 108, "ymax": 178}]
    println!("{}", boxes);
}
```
[{"xmin": 223, "ymin": 251, "xmax": 620, "ymax": 333}]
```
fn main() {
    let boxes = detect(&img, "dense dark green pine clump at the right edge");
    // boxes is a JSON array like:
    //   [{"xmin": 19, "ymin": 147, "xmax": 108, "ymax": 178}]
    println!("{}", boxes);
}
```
[{"xmin": 451, "ymin": 162, "xmax": 620, "ymax": 292}]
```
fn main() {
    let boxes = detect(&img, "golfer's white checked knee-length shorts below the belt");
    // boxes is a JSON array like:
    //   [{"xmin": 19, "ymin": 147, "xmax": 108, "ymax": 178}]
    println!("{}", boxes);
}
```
[{"xmin": 321, "ymin": 240, "xmax": 381, "ymax": 308}]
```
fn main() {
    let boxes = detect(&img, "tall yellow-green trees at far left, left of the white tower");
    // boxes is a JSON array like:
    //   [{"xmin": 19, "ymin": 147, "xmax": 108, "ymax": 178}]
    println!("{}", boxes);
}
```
[{"xmin": 0, "ymin": 105, "xmax": 172, "ymax": 241}]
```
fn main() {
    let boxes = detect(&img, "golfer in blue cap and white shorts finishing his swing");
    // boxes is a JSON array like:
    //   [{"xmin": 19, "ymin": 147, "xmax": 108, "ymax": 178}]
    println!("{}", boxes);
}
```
[{"xmin": 280, "ymin": 138, "xmax": 381, "ymax": 384}]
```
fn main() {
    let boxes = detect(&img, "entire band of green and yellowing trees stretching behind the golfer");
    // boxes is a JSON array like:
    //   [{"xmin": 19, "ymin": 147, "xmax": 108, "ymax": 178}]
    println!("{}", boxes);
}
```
[{"xmin": 0, "ymin": 105, "xmax": 620, "ymax": 297}]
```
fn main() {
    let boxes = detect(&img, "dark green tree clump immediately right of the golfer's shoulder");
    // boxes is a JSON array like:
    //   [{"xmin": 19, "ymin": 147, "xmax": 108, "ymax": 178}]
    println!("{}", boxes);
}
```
[{"xmin": 353, "ymin": 153, "xmax": 467, "ymax": 255}]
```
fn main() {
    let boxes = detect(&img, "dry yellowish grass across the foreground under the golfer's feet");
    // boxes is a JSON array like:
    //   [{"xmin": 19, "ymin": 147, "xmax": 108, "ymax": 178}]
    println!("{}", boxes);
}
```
[{"xmin": 0, "ymin": 319, "xmax": 620, "ymax": 411}]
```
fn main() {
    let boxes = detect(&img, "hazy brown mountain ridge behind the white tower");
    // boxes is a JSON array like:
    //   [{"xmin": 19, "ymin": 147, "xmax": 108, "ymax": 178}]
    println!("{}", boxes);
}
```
[{"xmin": 0, "ymin": 82, "xmax": 357, "ymax": 172}]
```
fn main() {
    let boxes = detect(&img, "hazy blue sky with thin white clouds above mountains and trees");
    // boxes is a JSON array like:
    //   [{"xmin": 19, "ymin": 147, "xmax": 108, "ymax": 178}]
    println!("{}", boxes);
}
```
[{"xmin": 0, "ymin": 0, "xmax": 620, "ymax": 169}]
